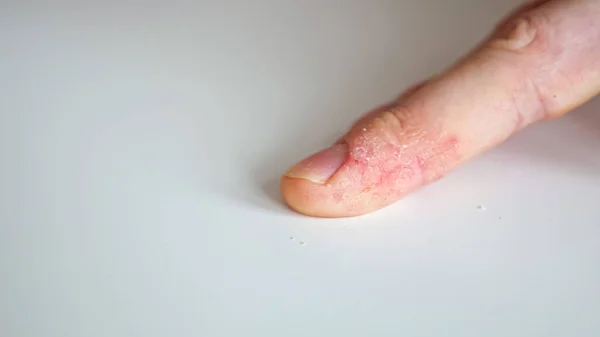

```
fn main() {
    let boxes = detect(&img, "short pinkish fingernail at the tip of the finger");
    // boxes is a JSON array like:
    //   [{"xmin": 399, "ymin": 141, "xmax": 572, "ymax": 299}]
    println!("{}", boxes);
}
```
[{"xmin": 285, "ymin": 143, "xmax": 348, "ymax": 184}]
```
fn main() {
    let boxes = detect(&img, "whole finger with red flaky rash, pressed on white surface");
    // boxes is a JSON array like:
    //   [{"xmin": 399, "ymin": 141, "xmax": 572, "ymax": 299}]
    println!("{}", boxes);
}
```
[{"xmin": 281, "ymin": 0, "xmax": 600, "ymax": 217}]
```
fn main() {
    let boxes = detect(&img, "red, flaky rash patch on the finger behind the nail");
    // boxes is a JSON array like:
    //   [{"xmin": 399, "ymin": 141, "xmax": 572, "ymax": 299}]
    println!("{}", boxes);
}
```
[{"xmin": 319, "ymin": 130, "xmax": 461, "ymax": 210}]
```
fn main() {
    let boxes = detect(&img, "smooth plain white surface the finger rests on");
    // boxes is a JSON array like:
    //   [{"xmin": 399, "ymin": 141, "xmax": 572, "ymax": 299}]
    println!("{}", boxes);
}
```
[{"xmin": 0, "ymin": 0, "xmax": 600, "ymax": 337}]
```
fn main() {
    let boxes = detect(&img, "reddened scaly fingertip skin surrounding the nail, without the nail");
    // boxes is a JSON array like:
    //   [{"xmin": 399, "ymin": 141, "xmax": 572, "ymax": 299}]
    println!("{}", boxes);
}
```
[{"xmin": 282, "ymin": 100, "xmax": 461, "ymax": 216}]
